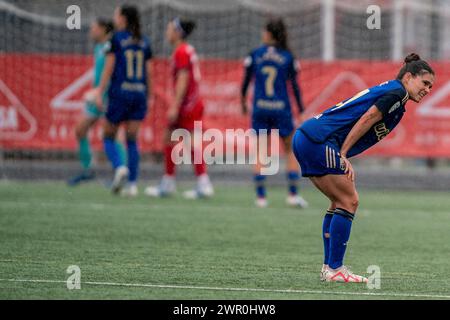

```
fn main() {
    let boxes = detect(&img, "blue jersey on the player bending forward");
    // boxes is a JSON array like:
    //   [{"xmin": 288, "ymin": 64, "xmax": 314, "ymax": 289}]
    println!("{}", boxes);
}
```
[{"xmin": 299, "ymin": 80, "xmax": 409, "ymax": 157}]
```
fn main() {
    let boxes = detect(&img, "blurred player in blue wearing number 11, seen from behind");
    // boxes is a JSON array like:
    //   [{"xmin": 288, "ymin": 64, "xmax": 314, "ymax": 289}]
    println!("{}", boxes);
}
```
[{"xmin": 97, "ymin": 5, "xmax": 152, "ymax": 196}]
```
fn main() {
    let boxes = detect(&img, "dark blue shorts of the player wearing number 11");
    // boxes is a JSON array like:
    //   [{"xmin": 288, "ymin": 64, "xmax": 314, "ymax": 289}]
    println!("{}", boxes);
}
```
[{"xmin": 105, "ymin": 93, "xmax": 147, "ymax": 124}]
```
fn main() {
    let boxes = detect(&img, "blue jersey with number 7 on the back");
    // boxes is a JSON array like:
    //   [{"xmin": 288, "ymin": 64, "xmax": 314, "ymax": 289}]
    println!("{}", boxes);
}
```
[{"xmin": 244, "ymin": 45, "xmax": 303, "ymax": 115}]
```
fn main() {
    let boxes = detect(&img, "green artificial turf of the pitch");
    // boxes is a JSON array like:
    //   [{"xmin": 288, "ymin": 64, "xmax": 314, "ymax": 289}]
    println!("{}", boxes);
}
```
[{"xmin": 0, "ymin": 182, "xmax": 450, "ymax": 299}]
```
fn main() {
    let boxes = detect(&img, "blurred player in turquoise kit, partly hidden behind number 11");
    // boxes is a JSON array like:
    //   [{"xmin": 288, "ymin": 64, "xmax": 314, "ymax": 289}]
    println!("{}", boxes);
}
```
[{"xmin": 68, "ymin": 18, "xmax": 126, "ymax": 186}]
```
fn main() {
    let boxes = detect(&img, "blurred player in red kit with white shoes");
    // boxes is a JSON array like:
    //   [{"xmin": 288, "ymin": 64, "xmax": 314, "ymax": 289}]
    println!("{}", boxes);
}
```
[{"xmin": 146, "ymin": 18, "xmax": 214, "ymax": 199}]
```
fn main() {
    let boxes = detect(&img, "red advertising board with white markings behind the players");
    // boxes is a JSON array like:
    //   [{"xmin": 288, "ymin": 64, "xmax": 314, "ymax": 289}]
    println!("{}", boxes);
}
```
[{"xmin": 0, "ymin": 54, "xmax": 450, "ymax": 157}]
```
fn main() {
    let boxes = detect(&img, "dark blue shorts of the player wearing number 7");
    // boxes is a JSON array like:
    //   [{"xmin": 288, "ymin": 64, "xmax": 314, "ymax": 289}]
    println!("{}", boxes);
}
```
[{"xmin": 252, "ymin": 112, "xmax": 294, "ymax": 138}]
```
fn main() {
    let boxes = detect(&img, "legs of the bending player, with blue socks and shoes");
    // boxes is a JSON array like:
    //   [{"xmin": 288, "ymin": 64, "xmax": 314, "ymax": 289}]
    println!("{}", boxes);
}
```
[{"xmin": 311, "ymin": 175, "xmax": 367, "ymax": 283}]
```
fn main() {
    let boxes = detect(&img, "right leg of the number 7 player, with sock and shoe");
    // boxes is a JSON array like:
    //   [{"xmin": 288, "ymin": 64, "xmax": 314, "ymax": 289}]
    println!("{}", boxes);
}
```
[{"xmin": 282, "ymin": 131, "xmax": 308, "ymax": 208}]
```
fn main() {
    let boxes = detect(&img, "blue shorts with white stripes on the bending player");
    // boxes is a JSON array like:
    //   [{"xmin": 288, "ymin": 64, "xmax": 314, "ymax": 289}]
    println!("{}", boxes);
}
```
[{"xmin": 292, "ymin": 129, "xmax": 345, "ymax": 177}]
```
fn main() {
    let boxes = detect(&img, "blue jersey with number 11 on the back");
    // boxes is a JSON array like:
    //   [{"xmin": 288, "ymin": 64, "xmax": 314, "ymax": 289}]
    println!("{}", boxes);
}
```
[{"xmin": 109, "ymin": 31, "xmax": 152, "ymax": 96}]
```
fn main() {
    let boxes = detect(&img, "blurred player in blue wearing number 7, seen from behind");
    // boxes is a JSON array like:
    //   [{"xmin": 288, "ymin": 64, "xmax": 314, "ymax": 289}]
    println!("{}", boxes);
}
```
[{"xmin": 241, "ymin": 19, "xmax": 308, "ymax": 208}]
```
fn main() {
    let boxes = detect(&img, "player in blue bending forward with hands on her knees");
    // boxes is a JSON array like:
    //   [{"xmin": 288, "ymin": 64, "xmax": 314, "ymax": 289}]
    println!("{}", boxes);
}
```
[{"xmin": 293, "ymin": 53, "xmax": 434, "ymax": 282}]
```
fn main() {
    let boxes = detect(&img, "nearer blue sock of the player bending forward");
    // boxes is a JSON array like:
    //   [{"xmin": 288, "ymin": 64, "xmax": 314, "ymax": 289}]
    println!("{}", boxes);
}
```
[{"xmin": 328, "ymin": 208, "xmax": 353, "ymax": 269}]
